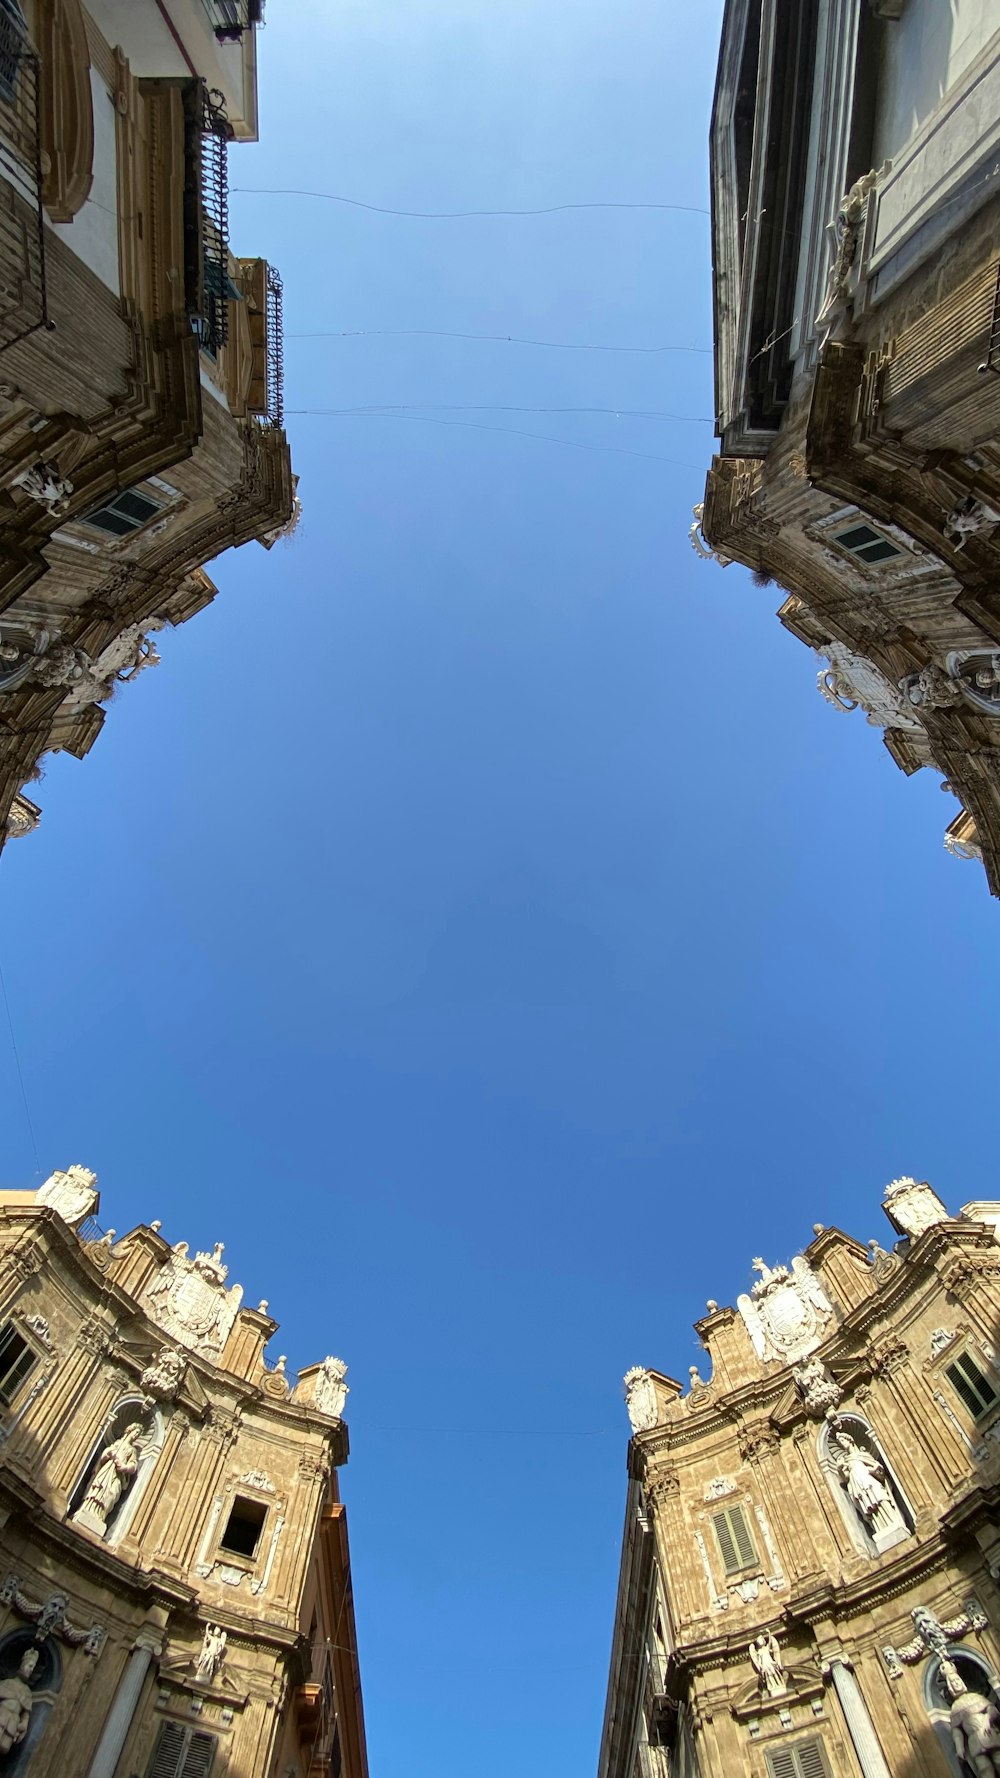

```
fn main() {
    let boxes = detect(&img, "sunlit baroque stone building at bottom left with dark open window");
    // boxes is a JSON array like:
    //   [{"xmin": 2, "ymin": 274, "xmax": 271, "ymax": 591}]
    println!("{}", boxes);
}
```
[{"xmin": 0, "ymin": 1166, "xmax": 361, "ymax": 1778}]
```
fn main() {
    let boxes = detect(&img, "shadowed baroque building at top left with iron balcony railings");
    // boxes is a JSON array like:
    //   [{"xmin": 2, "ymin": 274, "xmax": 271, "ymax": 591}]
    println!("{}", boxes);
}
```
[{"xmin": 0, "ymin": 0, "xmax": 297, "ymax": 845}]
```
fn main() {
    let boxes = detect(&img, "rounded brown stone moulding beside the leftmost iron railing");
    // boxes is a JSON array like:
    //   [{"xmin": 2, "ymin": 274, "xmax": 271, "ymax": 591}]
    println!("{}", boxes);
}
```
[{"xmin": 34, "ymin": 0, "xmax": 94, "ymax": 222}]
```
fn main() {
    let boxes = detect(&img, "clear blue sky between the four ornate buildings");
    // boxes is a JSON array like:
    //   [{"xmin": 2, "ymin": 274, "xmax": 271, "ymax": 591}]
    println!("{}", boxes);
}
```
[{"xmin": 0, "ymin": 0, "xmax": 1000, "ymax": 1778}]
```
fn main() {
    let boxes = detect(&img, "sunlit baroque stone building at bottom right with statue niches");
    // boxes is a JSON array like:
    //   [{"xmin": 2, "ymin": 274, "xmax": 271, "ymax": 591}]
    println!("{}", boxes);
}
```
[{"xmin": 600, "ymin": 1179, "xmax": 1000, "ymax": 1778}]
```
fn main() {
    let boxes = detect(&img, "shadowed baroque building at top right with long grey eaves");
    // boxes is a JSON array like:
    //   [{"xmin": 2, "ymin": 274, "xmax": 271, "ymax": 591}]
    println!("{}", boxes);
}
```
[{"xmin": 692, "ymin": 0, "xmax": 1000, "ymax": 894}]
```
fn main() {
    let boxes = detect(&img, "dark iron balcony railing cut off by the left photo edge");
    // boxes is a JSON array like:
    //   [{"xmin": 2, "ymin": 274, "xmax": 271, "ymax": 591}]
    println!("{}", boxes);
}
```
[{"xmin": 0, "ymin": 21, "xmax": 52, "ymax": 352}]
